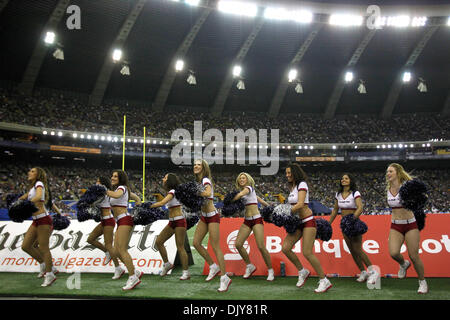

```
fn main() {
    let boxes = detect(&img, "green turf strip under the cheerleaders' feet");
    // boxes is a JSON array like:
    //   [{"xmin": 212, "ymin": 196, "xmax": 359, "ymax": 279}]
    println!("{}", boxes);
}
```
[{"xmin": 0, "ymin": 228, "xmax": 450, "ymax": 300}]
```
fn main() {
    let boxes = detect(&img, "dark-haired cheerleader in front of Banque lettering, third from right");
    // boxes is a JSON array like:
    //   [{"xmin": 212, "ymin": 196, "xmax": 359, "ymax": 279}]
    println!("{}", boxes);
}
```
[{"xmin": 282, "ymin": 163, "xmax": 333, "ymax": 293}]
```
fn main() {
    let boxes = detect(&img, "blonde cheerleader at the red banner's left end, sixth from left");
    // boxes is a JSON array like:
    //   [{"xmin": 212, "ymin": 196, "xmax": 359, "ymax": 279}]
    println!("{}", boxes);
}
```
[{"xmin": 233, "ymin": 172, "xmax": 275, "ymax": 281}]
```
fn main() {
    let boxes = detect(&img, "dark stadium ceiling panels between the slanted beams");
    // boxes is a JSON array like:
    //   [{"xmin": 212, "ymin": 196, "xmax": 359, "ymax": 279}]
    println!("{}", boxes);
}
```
[{"xmin": 0, "ymin": 0, "xmax": 450, "ymax": 115}]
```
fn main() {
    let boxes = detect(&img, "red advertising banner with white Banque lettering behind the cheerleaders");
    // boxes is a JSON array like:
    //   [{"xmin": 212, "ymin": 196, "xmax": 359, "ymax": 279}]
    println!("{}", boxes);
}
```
[{"xmin": 203, "ymin": 214, "xmax": 450, "ymax": 277}]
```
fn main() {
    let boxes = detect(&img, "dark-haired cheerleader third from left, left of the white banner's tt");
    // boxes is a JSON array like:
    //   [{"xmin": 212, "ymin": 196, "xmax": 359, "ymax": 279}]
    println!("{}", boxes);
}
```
[{"xmin": 106, "ymin": 170, "xmax": 143, "ymax": 290}]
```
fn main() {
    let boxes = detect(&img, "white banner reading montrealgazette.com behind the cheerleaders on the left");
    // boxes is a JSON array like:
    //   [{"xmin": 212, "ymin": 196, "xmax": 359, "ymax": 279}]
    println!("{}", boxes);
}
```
[{"xmin": 0, "ymin": 220, "xmax": 177, "ymax": 274}]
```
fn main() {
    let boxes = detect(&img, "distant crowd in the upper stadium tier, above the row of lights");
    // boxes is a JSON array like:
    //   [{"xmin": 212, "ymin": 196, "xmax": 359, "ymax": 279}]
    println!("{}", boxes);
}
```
[{"xmin": 0, "ymin": 89, "xmax": 450, "ymax": 143}]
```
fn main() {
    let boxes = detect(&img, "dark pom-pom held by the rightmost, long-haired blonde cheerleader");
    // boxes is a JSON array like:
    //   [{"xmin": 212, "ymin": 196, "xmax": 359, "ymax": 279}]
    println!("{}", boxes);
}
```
[{"xmin": 399, "ymin": 179, "xmax": 428, "ymax": 230}]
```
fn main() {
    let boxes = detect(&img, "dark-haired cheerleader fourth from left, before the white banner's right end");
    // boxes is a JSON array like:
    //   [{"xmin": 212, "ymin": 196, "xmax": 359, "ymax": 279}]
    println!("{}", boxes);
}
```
[{"xmin": 151, "ymin": 173, "xmax": 191, "ymax": 280}]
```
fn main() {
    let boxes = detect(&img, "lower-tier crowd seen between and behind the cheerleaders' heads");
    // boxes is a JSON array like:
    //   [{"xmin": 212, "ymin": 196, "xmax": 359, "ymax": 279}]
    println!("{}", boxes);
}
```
[{"xmin": 0, "ymin": 163, "xmax": 450, "ymax": 214}]
